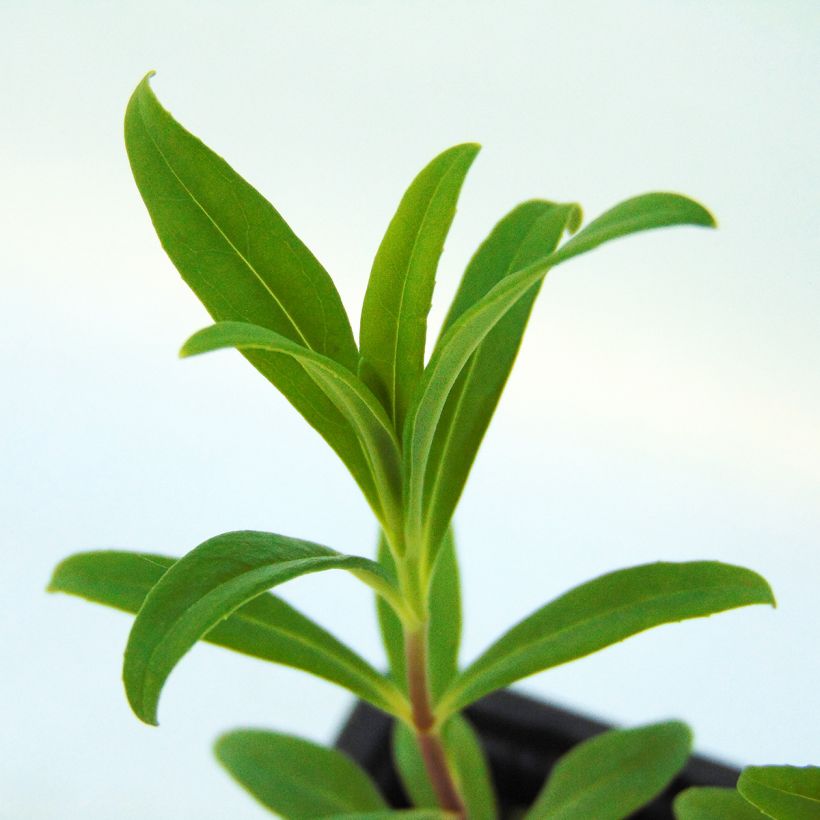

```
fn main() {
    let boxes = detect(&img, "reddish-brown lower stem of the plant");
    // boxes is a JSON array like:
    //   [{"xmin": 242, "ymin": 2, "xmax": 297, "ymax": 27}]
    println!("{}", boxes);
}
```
[{"xmin": 404, "ymin": 623, "xmax": 467, "ymax": 820}]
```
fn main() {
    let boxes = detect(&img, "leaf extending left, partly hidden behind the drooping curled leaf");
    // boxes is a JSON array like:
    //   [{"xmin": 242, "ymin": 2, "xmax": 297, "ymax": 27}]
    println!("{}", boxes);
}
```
[{"xmin": 49, "ymin": 551, "xmax": 406, "ymax": 712}]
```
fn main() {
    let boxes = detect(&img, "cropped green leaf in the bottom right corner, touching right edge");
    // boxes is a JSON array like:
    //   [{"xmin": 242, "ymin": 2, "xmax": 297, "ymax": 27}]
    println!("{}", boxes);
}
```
[{"xmin": 737, "ymin": 766, "xmax": 820, "ymax": 820}]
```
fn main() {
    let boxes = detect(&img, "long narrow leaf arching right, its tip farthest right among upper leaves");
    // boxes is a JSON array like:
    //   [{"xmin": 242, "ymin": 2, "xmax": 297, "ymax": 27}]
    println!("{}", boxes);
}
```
[{"xmin": 404, "ymin": 194, "xmax": 712, "ymax": 560}]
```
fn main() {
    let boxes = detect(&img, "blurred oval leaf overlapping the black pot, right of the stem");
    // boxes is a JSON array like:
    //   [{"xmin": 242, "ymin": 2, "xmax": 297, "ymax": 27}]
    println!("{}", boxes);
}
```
[{"xmin": 526, "ymin": 721, "xmax": 692, "ymax": 820}]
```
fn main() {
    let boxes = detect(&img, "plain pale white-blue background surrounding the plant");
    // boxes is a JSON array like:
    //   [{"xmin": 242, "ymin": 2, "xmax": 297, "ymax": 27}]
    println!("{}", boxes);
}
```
[{"xmin": 0, "ymin": 0, "xmax": 820, "ymax": 820}]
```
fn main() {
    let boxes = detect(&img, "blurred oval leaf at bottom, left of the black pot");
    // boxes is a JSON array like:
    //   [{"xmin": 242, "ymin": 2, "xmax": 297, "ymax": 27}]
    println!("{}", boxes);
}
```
[{"xmin": 214, "ymin": 729, "xmax": 387, "ymax": 820}]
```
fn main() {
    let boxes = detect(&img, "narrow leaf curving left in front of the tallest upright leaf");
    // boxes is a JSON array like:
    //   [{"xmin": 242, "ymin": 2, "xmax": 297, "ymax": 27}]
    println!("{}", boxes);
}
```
[{"xmin": 180, "ymin": 322, "xmax": 401, "ymax": 531}]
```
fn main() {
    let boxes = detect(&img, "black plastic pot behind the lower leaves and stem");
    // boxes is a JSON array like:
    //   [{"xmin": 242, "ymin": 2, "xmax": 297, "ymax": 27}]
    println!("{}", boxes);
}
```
[{"xmin": 336, "ymin": 692, "xmax": 739, "ymax": 820}]
